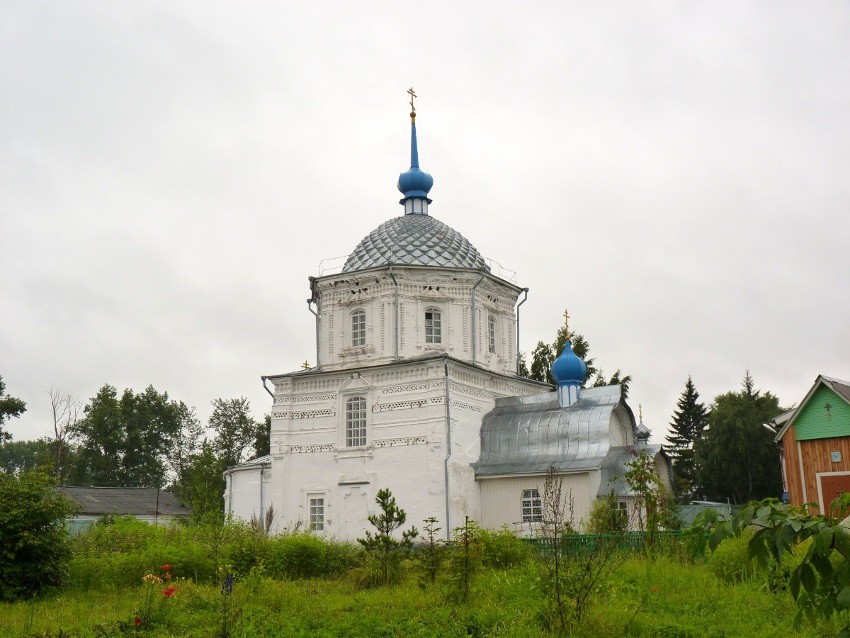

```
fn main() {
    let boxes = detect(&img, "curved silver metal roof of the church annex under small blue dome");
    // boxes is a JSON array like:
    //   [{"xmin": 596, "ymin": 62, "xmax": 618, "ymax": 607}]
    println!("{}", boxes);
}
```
[{"xmin": 473, "ymin": 385, "xmax": 636, "ymax": 477}]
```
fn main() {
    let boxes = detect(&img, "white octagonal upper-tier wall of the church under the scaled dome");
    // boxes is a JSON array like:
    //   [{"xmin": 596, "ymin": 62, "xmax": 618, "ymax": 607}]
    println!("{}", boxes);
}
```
[{"xmin": 314, "ymin": 267, "xmax": 521, "ymax": 374}]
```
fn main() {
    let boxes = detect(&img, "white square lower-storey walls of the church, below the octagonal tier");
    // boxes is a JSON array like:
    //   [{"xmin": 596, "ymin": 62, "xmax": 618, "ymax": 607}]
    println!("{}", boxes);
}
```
[{"xmin": 271, "ymin": 358, "xmax": 539, "ymax": 540}]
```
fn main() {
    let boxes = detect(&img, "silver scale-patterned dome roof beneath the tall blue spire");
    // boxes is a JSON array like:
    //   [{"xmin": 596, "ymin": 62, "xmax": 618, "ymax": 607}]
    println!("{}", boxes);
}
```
[{"xmin": 342, "ymin": 215, "xmax": 490, "ymax": 272}]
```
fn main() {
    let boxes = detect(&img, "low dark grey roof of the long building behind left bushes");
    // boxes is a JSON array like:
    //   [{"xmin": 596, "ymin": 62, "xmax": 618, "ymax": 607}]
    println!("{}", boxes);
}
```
[{"xmin": 55, "ymin": 487, "xmax": 191, "ymax": 516}]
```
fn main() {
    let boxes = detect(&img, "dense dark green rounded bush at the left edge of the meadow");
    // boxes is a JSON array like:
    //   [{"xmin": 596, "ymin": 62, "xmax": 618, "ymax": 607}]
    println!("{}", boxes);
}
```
[{"xmin": 0, "ymin": 470, "xmax": 74, "ymax": 600}]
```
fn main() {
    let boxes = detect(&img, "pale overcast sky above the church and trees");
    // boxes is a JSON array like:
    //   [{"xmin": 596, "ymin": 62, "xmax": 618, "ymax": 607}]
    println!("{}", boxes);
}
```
[{"xmin": 0, "ymin": 0, "xmax": 850, "ymax": 441}]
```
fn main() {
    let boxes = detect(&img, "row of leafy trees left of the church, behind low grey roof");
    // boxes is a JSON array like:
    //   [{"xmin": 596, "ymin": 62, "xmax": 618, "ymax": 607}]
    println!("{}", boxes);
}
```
[{"xmin": 0, "ymin": 377, "xmax": 271, "ymax": 516}]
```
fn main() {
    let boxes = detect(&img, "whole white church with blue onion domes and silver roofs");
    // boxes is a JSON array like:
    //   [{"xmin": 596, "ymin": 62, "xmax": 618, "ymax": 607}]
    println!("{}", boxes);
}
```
[{"xmin": 225, "ymin": 92, "xmax": 670, "ymax": 540}]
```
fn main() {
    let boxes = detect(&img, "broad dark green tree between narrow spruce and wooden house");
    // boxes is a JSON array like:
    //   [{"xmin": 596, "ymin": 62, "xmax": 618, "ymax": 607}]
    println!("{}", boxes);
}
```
[{"xmin": 694, "ymin": 372, "xmax": 782, "ymax": 503}]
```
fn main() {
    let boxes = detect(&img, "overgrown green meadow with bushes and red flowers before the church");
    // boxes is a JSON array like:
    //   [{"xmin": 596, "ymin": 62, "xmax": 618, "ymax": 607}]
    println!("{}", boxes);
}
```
[{"xmin": 0, "ymin": 519, "xmax": 843, "ymax": 638}]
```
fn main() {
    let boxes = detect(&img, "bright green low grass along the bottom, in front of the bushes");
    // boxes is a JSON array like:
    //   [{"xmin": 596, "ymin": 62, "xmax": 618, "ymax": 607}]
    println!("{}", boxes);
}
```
[{"xmin": 0, "ymin": 558, "xmax": 835, "ymax": 638}]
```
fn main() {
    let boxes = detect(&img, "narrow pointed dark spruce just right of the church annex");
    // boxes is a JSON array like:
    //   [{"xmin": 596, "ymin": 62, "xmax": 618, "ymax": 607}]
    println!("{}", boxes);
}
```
[{"xmin": 667, "ymin": 375, "xmax": 708, "ymax": 500}]
